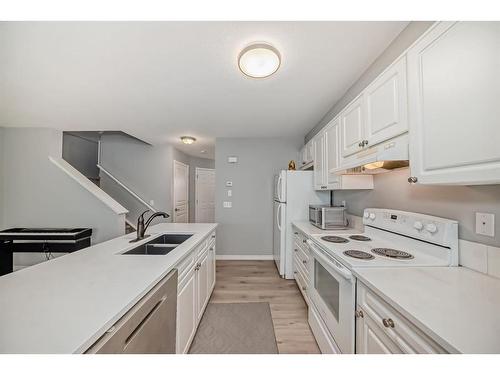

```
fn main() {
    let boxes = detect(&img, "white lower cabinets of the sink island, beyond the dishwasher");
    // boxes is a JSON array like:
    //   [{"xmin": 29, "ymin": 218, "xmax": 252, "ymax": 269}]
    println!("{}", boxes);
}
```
[{"xmin": 176, "ymin": 232, "xmax": 215, "ymax": 354}]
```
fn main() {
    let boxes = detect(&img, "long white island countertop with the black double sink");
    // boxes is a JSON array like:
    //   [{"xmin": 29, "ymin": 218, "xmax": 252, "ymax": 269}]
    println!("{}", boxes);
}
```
[{"xmin": 0, "ymin": 223, "xmax": 217, "ymax": 353}]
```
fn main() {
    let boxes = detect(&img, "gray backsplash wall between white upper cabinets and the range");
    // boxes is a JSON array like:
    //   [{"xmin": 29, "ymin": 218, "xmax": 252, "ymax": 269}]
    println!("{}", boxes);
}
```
[{"xmin": 334, "ymin": 168, "xmax": 500, "ymax": 246}]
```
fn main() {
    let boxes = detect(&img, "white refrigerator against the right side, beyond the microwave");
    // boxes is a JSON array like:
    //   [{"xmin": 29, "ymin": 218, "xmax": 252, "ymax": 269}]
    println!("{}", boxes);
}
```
[{"xmin": 273, "ymin": 170, "xmax": 330, "ymax": 279}]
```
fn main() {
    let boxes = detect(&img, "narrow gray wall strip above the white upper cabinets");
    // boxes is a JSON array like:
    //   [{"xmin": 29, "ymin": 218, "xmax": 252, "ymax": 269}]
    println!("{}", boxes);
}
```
[{"xmin": 305, "ymin": 21, "xmax": 434, "ymax": 142}]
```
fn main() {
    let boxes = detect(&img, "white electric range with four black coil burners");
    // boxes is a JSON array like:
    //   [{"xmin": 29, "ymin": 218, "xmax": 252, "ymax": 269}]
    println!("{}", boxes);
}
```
[{"xmin": 307, "ymin": 208, "xmax": 458, "ymax": 353}]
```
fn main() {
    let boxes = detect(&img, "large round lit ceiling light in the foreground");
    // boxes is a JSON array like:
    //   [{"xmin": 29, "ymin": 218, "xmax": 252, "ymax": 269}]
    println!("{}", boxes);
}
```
[{"xmin": 238, "ymin": 43, "xmax": 281, "ymax": 78}]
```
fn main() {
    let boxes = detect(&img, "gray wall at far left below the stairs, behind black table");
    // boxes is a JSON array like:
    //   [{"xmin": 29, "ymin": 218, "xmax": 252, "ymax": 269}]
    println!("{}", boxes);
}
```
[{"xmin": 0, "ymin": 128, "xmax": 125, "ymax": 243}]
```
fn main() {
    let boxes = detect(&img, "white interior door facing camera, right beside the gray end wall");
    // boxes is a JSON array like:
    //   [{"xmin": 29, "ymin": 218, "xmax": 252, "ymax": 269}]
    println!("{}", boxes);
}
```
[{"xmin": 195, "ymin": 168, "xmax": 215, "ymax": 223}]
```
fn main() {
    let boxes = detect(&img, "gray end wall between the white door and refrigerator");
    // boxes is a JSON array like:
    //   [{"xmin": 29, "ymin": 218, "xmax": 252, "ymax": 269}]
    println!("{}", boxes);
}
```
[{"xmin": 215, "ymin": 138, "xmax": 302, "ymax": 255}]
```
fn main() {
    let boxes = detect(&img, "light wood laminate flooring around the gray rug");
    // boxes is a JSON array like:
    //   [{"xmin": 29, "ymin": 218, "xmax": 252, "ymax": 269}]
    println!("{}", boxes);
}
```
[{"xmin": 210, "ymin": 260, "xmax": 320, "ymax": 354}]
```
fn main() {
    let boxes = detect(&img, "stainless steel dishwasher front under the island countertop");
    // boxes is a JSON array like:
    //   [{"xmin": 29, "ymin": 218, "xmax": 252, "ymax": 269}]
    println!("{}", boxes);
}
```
[{"xmin": 86, "ymin": 270, "xmax": 177, "ymax": 354}]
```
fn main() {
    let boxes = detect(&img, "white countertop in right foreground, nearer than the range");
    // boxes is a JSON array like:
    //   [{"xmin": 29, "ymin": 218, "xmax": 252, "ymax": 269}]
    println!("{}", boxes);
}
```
[{"xmin": 353, "ymin": 267, "xmax": 500, "ymax": 353}]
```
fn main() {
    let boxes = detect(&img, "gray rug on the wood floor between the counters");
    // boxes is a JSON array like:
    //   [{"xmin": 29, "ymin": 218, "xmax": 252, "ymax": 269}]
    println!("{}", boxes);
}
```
[{"xmin": 189, "ymin": 302, "xmax": 278, "ymax": 354}]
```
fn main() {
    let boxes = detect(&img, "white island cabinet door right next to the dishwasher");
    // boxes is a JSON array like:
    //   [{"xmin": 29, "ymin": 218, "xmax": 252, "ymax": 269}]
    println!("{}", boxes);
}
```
[{"xmin": 176, "ymin": 270, "xmax": 198, "ymax": 354}]
